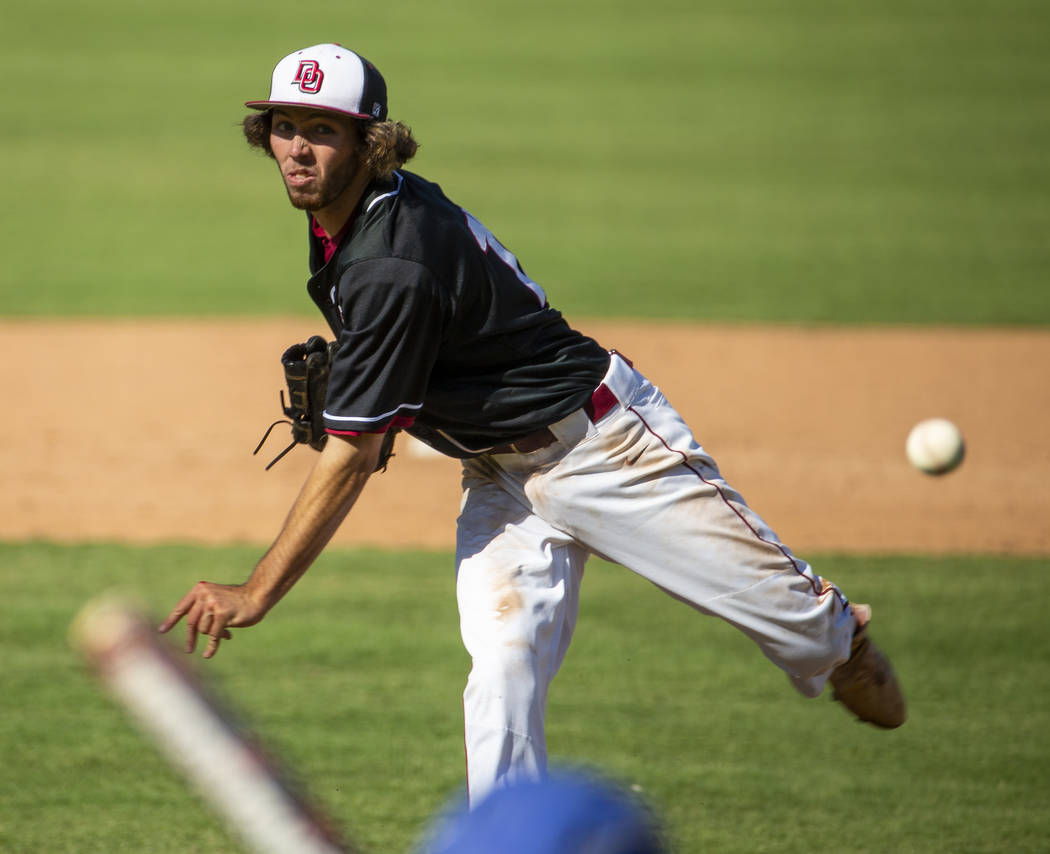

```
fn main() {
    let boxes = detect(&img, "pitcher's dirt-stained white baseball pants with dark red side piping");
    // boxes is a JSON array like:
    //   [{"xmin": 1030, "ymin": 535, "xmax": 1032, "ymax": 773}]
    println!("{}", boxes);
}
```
[{"xmin": 456, "ymin": 353, "xmax": 856, "ymax": 803}]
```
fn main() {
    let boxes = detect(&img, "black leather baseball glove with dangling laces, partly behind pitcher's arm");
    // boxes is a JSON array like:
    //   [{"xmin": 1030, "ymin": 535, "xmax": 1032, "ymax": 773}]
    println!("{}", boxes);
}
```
[{"xmin": 252, "ymin": 335, "xmax": 397, "ymax": 472}]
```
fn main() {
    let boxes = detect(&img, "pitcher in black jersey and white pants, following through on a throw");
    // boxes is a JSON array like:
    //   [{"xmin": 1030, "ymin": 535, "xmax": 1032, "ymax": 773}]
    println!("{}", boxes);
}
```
[{"xmin": 160, "ymin": 44, "xmax": 905, "ymax": 801}]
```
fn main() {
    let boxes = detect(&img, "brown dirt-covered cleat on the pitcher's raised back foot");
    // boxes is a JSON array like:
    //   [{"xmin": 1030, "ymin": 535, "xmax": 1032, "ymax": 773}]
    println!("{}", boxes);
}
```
[{"xmin": 830, "ymin": 623, "xmax": 907, "ymax": 729}]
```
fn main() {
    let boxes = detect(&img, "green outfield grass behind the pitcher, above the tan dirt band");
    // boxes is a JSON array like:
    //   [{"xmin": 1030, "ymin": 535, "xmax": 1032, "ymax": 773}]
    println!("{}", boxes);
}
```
[{"xmin": 0, "ymin": 0, "xmax": 1050, "ymax": 325}]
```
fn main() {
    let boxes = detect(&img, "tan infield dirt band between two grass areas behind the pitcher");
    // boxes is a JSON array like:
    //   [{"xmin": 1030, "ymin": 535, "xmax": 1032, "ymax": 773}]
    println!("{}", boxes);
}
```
[{"xmin": 8, "ymin": 318, "xmax": 1050, "ymax": 555}]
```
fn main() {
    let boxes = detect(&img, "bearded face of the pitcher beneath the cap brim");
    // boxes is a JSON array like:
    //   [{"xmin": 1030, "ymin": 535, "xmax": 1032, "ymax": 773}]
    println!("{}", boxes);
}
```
[{"xmin": 270, "ymin": 107, "xmax": 358, "ymax": 213}]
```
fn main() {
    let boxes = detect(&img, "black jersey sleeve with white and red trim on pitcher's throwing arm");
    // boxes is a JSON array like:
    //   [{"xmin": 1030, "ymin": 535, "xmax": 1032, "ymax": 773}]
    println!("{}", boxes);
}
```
[{"xmin": 324, "ymin": 257, "xmax": 448, "ymax": 435}]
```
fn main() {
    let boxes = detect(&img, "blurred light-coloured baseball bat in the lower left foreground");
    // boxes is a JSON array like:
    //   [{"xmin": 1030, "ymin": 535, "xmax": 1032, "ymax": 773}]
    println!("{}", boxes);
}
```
[{"xmin": 69, "ymin": 597, "xmax": 355, "ymax": 854}]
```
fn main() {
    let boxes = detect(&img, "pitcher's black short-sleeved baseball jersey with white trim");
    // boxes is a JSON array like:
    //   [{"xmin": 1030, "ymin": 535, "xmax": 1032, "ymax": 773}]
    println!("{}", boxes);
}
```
[{"xmin": 308, "ymin": 171, "xmax": 609, "ymax": 458}]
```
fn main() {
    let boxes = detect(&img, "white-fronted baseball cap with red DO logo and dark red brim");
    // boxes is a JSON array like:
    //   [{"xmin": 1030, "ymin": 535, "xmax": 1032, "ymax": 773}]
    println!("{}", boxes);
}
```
[{"xmin": 245, "ymin": 44, "xmax": 386, "ymax": 121}]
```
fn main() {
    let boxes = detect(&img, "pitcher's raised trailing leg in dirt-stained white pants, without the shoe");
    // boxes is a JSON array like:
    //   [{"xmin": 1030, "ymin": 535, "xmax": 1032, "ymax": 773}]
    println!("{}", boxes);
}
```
[{"xmin": 524, "ymin": 363, "xmax": 856, "ymax": 696}]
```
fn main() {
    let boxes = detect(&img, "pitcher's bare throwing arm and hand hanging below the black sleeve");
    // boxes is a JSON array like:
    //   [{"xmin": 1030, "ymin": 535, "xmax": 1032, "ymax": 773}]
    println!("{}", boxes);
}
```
[{"xmin": 159, "ymin": 433, "xmax": 383, "ymax": 659}]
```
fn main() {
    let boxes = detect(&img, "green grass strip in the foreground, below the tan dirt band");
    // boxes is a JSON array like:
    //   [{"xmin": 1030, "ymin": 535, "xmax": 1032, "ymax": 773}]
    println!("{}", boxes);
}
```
[{"xmin": 0, "ymin": 544, "xmax": 1050, "ymax": 854}]
